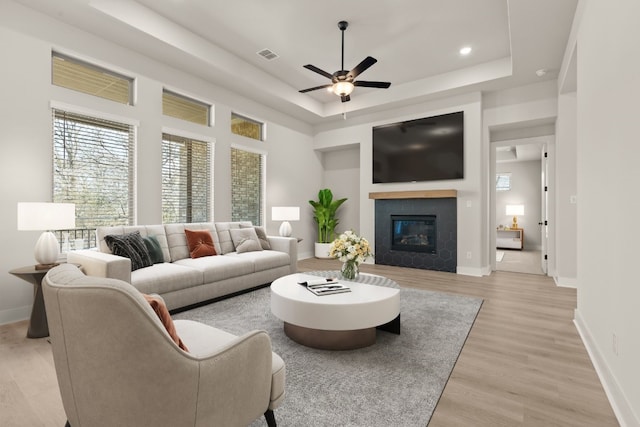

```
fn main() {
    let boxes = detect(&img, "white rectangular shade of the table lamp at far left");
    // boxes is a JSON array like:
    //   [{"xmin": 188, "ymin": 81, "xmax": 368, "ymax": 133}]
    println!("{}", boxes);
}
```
[{"xmin": 18, "ymin": 202, "xmax": 76, "ymax": 231}]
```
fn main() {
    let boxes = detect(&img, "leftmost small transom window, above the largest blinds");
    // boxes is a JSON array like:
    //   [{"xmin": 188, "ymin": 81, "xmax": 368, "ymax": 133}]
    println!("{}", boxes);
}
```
[{"xmin": 51, "ymin": 52, "xmax": 133, "ymax": 105}]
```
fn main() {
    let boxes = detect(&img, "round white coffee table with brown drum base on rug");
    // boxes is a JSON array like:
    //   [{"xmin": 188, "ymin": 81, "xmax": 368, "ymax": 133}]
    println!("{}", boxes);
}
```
[{"xmin": 271, "ymin": 272, "xmax": 400, "ymax": 350}]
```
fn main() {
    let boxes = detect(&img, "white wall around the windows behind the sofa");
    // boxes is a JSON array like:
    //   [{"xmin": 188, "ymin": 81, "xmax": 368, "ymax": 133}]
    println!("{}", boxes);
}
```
[{"xmin": 0, "ymin": 2, "xmax": 323, "ymax": 326}]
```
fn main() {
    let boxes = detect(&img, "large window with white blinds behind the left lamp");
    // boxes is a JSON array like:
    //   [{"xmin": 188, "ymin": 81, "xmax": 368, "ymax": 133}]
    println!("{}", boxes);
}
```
[{"xmin": 53, "ymin": 109, "xmax": 135, "ymax": 228}]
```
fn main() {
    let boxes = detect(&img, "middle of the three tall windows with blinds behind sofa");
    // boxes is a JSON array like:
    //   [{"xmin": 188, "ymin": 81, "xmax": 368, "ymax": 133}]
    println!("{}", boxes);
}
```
[{"xmin": 162, "ymin": 133, "xmax": 212, "ymax": 224}]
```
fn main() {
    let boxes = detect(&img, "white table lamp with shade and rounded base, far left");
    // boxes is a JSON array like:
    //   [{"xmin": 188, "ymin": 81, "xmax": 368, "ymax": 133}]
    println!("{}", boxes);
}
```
[{"xmin": 18, "ymin": 202, "xmax": 76, "ymax": 270}]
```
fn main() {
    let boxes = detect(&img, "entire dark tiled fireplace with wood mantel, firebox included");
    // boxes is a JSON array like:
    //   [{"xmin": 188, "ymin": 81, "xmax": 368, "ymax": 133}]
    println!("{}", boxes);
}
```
[{"xmin": 369, "ymin": 190, "xmax": 458, "ymax": 273}]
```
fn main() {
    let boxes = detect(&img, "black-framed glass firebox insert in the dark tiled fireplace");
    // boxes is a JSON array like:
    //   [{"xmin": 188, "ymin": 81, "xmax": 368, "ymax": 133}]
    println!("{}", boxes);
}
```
[{"xmin": 391, "ymin": 215, "xmax": 437, "ymax": 254}]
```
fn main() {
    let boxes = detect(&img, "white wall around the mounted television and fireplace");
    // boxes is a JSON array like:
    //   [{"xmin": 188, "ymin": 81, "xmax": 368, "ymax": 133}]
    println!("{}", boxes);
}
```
[{"xmin": 314, "ymin": 93, "xmax": 488, "ymax": 276}]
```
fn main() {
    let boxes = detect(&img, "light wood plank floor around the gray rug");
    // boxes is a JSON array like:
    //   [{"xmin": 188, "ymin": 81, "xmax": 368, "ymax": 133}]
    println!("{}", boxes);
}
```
[{"xmin": 0, "ymin": 259, "xmax": 618, "ymax": 427}]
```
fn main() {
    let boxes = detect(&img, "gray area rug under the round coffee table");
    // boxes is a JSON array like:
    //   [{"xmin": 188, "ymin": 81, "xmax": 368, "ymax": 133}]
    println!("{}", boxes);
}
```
[{"xmin": 173, "ymin": 276, "xmax": 482, "ymax": 427}]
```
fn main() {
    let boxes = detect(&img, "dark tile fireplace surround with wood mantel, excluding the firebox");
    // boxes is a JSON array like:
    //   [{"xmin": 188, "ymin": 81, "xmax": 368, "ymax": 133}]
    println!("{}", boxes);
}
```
[{"xmin": 369, "ymin": 190, "xmax": 458, "ymax": 273}]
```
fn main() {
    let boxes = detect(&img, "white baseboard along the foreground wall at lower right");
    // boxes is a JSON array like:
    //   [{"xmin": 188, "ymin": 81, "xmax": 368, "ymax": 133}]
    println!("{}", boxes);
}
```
[{"xmin": 573, "ymin": 309, "xmax": 640, "ymax": 427}]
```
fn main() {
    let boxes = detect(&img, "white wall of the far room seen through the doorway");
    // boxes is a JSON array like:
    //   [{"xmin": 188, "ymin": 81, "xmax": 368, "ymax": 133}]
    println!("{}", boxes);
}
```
[{"xmin": 496, "ymin": 160, "xmax": 542, "ymax": 250}]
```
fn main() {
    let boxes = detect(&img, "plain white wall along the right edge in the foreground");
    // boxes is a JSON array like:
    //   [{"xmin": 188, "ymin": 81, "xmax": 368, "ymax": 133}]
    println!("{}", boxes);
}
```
[{"xmin": 576, "ymin": 0, "xmax": 640, "ymax": 426}]
